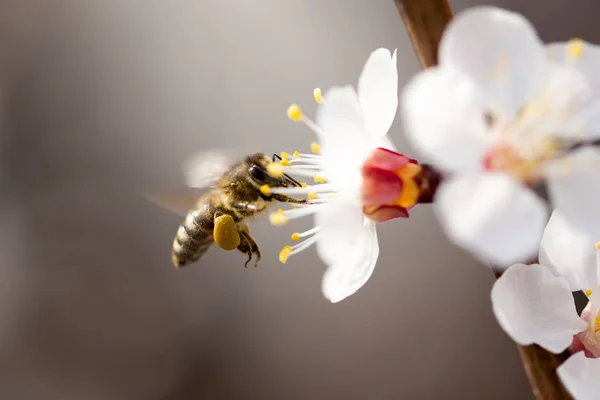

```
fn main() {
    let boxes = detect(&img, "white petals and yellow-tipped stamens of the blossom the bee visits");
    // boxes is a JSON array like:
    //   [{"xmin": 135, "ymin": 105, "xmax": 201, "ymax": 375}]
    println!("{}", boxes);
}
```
[{"xmin": 271, "ymin": 49, "xmax": 418, "ymax": 303}]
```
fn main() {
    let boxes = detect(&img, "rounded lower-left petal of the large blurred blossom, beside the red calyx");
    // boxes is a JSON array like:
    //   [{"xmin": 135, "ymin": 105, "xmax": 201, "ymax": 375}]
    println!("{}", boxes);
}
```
[{"xmin": 434, "ymin": 173, "xmax": 547, "ymax": 267}]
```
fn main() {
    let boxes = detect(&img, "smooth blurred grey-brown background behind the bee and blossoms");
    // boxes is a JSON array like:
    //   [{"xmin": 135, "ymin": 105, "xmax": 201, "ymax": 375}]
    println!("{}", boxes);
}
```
[{"xmin": 0, "ymin": 0, "xmax": 600, "ymax": 400}]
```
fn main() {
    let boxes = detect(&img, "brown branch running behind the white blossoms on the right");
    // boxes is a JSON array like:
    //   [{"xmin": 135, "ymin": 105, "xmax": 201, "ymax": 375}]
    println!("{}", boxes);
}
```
[{"xmin": 394, "ymin": 0, "xmax": 572, "ymax": 400}]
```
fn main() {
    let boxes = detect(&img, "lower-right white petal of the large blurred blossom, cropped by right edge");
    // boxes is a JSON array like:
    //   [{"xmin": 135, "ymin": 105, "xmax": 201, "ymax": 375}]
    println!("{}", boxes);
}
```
[{"xmin": 547, "ymin": 147, "xmax": 600, "ymax": 241}]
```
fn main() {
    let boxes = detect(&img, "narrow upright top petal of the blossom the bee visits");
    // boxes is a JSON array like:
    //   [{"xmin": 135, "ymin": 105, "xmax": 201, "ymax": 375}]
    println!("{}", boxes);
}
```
[{"xmin": 358, "ymin": 48, "xmax": 398, "ymax": 138}]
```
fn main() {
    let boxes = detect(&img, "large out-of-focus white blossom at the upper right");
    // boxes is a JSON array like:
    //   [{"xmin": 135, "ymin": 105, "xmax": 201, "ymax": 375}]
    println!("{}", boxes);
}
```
[{"xmin": 402, "ymin": 7, "xmax": 600, "ymax": 266}]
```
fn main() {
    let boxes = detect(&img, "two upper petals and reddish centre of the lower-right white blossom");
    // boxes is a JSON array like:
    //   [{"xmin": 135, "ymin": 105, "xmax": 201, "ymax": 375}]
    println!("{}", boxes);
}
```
[{"xmin": 492, "ymin": 210, "xmax": 600, "ymax": 356}]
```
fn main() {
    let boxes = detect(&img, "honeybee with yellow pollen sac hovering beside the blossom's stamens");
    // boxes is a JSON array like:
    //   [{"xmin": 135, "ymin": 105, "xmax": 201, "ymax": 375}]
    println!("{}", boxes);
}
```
[{"xmin": 146, "ymin": 152, "xmax": 306, "ymax": 268}]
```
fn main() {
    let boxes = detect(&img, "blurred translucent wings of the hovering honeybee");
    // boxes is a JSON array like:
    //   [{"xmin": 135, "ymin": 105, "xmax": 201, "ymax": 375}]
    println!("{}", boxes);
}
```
[{"xmin": 145, "ymin": 149, "xmax": 244, "ymax": 216}]
